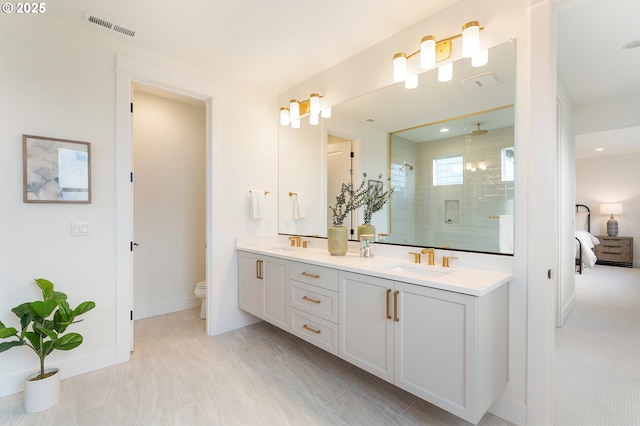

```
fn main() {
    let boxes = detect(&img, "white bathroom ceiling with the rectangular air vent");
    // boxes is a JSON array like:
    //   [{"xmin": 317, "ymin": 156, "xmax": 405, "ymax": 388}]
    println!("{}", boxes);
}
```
[{"xmin": 47, "ymin": 0, "xmax": 457, "ymax": 93}]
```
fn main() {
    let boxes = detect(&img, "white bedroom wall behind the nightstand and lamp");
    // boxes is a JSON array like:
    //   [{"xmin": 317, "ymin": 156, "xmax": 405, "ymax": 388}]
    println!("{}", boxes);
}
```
[{"xmin": 576, "ymin": 154, "xmax": 640, "ymax": 267}]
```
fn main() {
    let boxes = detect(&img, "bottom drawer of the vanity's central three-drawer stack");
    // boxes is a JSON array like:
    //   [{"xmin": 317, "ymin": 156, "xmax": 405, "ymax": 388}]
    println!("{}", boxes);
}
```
[{"xmin": 289, "ymin": 308, "xmax": 338, "ymax": 355}]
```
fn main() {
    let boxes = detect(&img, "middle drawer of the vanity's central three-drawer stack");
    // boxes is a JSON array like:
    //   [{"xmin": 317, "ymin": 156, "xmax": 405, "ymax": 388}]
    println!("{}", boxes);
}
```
[{"xmin": 289, "ymin": 280, "xmax": 338, "ymax": 323}]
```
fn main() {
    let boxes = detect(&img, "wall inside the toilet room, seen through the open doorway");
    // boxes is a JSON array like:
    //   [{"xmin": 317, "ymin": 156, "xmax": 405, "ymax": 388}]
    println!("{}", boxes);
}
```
[{"xmin": 133, "ymin": 90, "xmax": 207, "ymax": 319}]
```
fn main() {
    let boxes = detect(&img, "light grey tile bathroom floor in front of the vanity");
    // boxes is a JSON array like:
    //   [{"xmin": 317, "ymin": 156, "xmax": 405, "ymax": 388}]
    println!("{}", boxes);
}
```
[{"xmin": 0, "ymin": 308, "xmax": 510, "ymax": 426}]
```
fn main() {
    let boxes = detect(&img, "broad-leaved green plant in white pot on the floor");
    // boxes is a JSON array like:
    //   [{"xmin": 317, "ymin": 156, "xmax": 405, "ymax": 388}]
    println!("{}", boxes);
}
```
[{"xmin": 0, "ymin": 278, "xmax": 96, "ymax": 413}]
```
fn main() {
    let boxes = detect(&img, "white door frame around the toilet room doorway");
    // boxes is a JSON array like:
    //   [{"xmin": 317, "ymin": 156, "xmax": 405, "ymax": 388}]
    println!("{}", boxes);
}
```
[{"xmin": 115, "ymin": 55, "xmax": 221, "ymax": 362}]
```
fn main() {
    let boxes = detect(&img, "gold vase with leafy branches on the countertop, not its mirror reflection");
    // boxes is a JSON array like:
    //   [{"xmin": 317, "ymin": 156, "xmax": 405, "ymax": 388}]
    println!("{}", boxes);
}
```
[{"xmin": 327, "ymin": 173, "xmax": 367, "ymax": 256}]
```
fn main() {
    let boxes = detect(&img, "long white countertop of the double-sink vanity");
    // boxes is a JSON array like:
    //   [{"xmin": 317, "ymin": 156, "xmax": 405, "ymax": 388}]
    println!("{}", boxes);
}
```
[{"xmin": 236, "ymin": 244, "xmax": 513, "ymax": 296}]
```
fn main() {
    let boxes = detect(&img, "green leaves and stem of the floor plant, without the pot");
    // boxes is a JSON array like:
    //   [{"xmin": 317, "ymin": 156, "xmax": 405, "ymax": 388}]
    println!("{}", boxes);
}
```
[{"xmin": 0, "ymin": 278, "xmax": 96, "ymax": 380}]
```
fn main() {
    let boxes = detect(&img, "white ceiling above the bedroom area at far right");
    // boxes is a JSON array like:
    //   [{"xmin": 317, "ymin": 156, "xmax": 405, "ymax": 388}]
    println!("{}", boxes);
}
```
[{"xmin": 557, "ymin": 0, "xmax": 640, "ymax": 158}]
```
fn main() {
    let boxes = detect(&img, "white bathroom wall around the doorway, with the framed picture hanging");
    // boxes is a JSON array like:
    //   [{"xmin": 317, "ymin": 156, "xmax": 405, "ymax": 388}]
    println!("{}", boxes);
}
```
[{"xmin": 0, "ymin": 15, "xmax": 278, "ymax": 396}]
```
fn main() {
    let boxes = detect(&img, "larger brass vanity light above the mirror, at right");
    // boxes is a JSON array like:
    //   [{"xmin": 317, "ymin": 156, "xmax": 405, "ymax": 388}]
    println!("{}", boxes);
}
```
[{"xmin": 393, "ymin": 21, "xmax": 489, "ymax": 89}]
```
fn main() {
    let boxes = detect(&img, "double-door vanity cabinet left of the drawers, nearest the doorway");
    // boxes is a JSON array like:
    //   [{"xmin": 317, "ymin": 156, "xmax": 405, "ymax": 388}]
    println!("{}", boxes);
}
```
[{"xmin": 238, "ymin": 251, "xmax": 289, "ymax": 331}]
